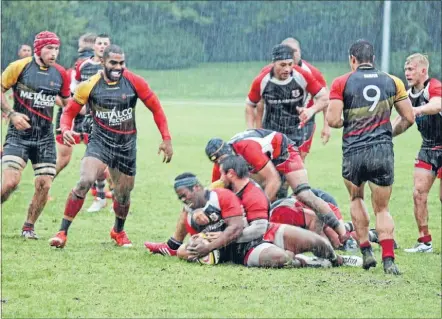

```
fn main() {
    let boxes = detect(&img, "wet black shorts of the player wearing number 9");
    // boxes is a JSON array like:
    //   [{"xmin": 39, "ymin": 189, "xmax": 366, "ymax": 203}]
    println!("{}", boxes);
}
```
[{"xmin": 342, "ymin": 143, "xmax": 394, "ymax": 186}]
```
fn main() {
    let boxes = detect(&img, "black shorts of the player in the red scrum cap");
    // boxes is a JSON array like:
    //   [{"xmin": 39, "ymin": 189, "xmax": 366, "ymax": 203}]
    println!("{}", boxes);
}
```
[{"xmin": 3, "ymin": 132, "xmax": 57, "ymax": 165}]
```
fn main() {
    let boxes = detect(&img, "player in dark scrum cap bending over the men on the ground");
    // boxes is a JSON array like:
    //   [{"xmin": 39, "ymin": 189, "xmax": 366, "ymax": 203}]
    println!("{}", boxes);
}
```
[{"xmin": 206, "ymin": 129, "xmax": 348, "ymax": 243}]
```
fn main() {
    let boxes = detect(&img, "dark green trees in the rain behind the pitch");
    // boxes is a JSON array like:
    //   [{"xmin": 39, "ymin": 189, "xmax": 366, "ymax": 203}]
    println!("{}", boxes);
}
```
[{"xmin": 1, "ymin": 1, "xmax": 441, "ymax": 78}]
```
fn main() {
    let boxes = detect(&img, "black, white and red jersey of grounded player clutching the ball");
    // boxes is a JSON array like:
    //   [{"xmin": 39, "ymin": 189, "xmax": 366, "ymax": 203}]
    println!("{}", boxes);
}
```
[{"xmin": 187, "ymin": 188, "xmax": 244, "ymax": 233}]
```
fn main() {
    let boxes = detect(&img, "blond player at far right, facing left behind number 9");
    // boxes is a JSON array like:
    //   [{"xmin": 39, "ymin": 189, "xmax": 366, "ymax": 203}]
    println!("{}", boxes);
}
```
[{"xmin": 393, "ymin": 53, "xmax": 442, "ymax": 253}]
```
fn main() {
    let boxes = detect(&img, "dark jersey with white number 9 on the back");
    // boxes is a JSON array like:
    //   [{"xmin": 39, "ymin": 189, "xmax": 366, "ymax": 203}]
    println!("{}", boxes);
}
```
[{"xmin": 330, "ymin": 64, "xmax": 407, "ymax": 154}]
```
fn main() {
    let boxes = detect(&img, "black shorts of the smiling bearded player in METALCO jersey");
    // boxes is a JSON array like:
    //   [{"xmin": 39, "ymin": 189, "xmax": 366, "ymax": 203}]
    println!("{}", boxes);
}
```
[{"xmin": 84, "ymin": 135, "xmax": 137, "ymax": 176}]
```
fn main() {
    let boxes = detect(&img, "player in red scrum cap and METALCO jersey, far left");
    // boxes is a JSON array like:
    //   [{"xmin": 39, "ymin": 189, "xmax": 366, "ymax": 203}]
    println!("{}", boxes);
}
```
[{"xmin": 1, "ymin": 31, "xmax": 69, "ymax": 239}]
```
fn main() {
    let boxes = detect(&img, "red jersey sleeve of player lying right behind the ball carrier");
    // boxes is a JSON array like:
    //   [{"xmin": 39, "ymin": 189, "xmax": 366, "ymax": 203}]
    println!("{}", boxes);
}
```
[{"xmin": 236, "ymin": 180, "xmax": 270, "ymax": 223}]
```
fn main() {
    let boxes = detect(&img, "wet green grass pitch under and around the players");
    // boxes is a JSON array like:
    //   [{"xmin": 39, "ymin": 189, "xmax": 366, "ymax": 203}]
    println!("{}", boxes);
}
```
[{"xmin": 1, "ymin": 62, "xmax": 441, "ymax": 318}]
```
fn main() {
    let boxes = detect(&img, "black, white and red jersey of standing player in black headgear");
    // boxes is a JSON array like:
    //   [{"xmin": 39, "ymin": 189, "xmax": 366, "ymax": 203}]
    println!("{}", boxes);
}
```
[{"xmin": 247, "ymin": 65, "xmax": 324, "ymax": 135}]
